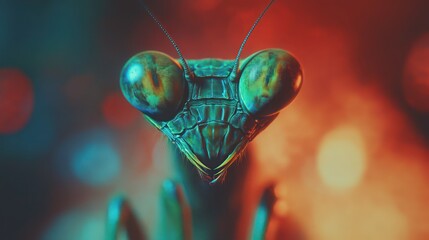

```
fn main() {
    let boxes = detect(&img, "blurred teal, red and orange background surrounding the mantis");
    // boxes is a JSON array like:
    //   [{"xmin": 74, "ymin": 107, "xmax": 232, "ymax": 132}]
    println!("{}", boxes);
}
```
[{"xmin": 0, "ymin": 0, "xmax": 429, "ymax": 240}]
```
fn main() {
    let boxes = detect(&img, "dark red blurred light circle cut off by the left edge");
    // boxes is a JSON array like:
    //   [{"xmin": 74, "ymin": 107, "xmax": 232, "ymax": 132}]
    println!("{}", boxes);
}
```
[{"xmin": 0, "ymin": 69, "xmax": 34, "ymax": 134}]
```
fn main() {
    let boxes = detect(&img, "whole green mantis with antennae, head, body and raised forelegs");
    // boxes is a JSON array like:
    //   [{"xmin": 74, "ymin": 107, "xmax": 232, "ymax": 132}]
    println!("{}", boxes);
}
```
[{"xmin": 108, "ymin": 0, "xmax": 302, "ymax": 239}]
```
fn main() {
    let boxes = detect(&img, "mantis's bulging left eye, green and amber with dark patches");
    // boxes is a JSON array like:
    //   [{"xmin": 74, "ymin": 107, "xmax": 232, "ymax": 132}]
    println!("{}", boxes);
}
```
[{"xmin": 120, "ymin": 51, "xmax": 187, "ymax": 121}]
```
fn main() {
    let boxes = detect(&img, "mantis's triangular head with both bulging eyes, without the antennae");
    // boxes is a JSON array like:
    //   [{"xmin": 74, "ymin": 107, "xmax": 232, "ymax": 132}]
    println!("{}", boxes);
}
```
[{"xmin": 120, "ymin": 49, "xmax": 302, "ymax": 183}]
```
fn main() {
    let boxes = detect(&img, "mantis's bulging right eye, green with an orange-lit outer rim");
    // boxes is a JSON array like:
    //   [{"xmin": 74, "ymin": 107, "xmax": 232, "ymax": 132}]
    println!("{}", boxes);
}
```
[{"xmin": 238, "ymin": 49, "xmax": 302, "ymax": 117}]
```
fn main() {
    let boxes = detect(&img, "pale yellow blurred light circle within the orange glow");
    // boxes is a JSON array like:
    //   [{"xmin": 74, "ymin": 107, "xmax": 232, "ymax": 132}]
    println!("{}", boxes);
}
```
[{"xmin": 317, "ymin": 126, "xmax": 366, "ymax": 190}]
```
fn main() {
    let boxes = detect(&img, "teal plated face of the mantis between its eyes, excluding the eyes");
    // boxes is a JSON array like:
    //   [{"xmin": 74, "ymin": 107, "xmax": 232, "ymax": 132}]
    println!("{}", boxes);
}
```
[{"xmin": 148, "ymin": 59, "xmax": 274, "ymax": 181}]
